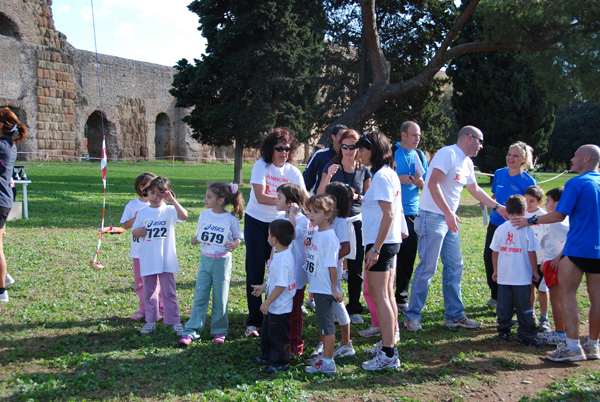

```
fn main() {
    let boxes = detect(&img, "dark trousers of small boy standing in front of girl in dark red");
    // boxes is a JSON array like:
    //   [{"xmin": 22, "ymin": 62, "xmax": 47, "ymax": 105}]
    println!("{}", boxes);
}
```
[{"xmin": 260, "ymin": 313, "xmax": 290, "ymax": 366}]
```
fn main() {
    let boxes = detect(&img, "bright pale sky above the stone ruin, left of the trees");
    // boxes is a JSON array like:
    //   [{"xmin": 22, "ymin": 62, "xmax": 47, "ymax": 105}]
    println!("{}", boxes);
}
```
[{"xmin": 52, "ymin": 0, "xmax": 205, "ymax": 66}]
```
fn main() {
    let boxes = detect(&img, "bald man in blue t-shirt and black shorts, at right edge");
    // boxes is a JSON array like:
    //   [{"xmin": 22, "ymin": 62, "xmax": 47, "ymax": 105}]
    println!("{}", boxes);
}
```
[{"xmin": 513, "ymin": 144, "xmax": 600, "ymax": 362}]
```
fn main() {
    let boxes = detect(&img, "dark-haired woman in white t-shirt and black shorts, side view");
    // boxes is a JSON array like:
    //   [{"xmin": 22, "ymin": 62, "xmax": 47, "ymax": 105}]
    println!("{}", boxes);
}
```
[{"xmin": 356, "ymin": 131, "xmax": 403, "ymax": 370}]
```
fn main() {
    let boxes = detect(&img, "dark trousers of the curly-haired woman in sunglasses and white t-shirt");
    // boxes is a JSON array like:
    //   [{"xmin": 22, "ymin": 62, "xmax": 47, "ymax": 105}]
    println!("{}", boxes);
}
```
[{"xmin": 244, "ymin": 214, "xmax": 271, "ymax": 328}]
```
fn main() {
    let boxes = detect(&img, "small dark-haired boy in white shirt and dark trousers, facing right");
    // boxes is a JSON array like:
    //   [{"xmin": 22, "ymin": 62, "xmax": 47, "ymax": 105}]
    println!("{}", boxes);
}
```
[{"xmin": 252, "ymin": 219, "xmax": 296, "ymax": 374}]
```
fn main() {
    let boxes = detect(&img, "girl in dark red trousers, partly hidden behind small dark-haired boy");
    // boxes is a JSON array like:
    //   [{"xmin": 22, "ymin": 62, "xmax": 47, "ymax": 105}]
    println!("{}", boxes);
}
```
[{"xmin": 271, "ymin": 183, "xmax": 308, "ymax": 356}]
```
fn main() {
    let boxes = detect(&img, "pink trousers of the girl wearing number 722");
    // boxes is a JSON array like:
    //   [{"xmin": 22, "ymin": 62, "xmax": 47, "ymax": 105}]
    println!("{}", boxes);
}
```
[{"xmin": 142, "ymin": 272, "xmax": 180, "ymax": 325}]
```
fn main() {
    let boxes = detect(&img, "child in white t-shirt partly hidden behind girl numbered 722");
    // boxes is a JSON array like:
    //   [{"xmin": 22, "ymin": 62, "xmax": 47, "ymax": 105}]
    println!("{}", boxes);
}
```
[{"xmin": 121, "ymin": 172, "xmax": 162, "ymax": 321}]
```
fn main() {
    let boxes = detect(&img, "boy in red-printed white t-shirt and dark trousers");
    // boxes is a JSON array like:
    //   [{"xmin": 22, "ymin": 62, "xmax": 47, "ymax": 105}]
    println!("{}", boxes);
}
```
[{"xmin": 490, "ymin": 195, "xmax": 544, "ymax": 347}]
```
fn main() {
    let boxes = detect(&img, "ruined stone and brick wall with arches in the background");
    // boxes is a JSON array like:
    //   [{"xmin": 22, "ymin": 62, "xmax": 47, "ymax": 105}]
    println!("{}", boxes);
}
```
[{"xmin": 0, "ymin": 0, "xmax": 241, "ymax": 160}]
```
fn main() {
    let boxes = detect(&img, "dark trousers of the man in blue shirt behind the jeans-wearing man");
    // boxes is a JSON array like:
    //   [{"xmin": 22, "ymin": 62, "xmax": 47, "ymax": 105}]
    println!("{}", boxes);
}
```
[{"xmin": 396, "ymin": 215, "xmax": 419, "ymax": 304}]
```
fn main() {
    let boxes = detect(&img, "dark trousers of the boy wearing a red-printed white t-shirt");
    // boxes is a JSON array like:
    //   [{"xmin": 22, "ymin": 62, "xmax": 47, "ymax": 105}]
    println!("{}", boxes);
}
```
[{"xmin": 496, "ymin": 285, "xmax": 537, "ymax": 339}]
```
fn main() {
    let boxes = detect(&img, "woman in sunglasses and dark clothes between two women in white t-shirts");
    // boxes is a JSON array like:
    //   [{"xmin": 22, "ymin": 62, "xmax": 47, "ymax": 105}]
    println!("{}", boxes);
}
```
[{"xmin": 317, "ymin": 129, "xmax": 371, "ymax": 324}]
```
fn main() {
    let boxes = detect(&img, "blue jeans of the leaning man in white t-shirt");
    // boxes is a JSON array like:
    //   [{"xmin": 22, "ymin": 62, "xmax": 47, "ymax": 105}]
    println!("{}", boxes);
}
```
[{"xmin": 406, "ymin": 210, "xmax": 465, "ymax": 320}]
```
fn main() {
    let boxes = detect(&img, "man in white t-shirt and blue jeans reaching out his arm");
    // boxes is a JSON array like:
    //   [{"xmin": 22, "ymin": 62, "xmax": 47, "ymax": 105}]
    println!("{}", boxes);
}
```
[{"xmin": 404, "ymin": 126, "xmax": 507, "ymax": 331}]
